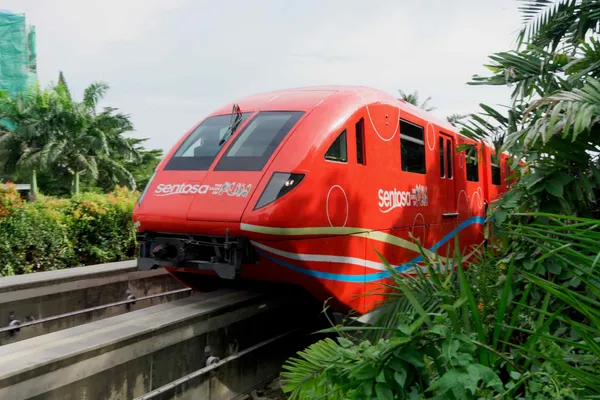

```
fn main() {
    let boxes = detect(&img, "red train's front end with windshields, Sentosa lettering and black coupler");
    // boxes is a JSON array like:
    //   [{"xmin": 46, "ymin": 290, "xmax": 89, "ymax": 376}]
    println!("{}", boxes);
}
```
[{"xmin": 133, "ymin": 89, "xmax": 332, "ymax": 287}]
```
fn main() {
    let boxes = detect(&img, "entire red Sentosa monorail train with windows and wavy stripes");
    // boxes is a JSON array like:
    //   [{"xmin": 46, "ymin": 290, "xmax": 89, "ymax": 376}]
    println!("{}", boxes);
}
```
[{"xmin": 133, "ymin": 86, "xmax": 509, "ymax": 313}]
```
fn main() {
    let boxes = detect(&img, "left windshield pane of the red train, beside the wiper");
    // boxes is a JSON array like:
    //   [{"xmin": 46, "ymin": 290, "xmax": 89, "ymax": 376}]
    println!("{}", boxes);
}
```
[{"xmin": 165, "ymin": 112, "xmax": 252, "ymax": 171}]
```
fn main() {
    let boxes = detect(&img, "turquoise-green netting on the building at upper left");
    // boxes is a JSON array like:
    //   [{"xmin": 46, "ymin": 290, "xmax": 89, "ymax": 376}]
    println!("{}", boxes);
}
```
[{"xmin": 0, "ymin": 12, "xmax": 37, "ymax": 96}]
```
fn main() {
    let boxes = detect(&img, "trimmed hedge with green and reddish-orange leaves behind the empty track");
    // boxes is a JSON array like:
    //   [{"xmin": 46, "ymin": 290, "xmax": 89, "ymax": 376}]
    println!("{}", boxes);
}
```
[{"xmin": 0, "ymin": 185, "xmax": 138, "ymax": 276}]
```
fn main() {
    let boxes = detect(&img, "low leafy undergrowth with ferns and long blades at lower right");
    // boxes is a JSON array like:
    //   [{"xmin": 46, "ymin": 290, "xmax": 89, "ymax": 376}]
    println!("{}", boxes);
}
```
[{"xmin": 281, "ymin": 214, "xmax": 600, "ymax": 399}]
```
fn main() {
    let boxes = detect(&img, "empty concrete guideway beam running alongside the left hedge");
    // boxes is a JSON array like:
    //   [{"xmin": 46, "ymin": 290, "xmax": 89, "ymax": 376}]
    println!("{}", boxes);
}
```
[{"xmin": 0, "ymin": 260, "xmax": 191, "ymax": 345}]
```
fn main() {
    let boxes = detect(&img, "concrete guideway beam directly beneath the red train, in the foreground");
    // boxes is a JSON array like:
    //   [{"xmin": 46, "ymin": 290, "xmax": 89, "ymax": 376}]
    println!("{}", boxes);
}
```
[{"xmin": 0, "ymin": 289, "xmax": 318, "ymax": 400}]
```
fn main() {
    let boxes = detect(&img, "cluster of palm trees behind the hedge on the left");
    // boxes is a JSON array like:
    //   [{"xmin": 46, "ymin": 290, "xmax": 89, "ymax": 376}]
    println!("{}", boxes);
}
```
[{"xmin": 0, "ymin": 73, "xmax": 139, "ymax": 193}]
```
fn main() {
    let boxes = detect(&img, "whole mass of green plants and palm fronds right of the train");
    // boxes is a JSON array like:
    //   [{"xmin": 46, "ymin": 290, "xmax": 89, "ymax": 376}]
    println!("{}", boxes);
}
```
[{"xmin": 281, "ymin": 0, "xmax": 600, "ymax": 399}]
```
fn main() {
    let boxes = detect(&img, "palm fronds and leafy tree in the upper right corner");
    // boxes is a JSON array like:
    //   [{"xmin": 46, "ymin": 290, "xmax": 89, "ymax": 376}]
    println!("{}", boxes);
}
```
[{"xmin": 463, "ymin": 0, "xmax": 600, "ymax": 217}]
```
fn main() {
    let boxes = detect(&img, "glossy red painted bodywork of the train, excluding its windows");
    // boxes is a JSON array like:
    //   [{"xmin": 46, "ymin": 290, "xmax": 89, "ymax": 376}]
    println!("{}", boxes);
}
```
[{"xmin": 134, "ymin": 86, "xmax": 508, "ymax": 313}]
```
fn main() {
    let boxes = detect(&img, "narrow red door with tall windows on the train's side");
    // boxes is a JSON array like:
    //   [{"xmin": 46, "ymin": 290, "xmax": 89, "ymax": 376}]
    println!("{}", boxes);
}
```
[{"xmin": 438, "ymin": 132, "xmax": 458, "ymax": 218}]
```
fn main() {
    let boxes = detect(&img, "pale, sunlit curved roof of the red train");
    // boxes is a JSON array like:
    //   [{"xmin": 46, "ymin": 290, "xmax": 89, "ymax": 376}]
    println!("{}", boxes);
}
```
[{"xmin": 211, "ymin": 85, "xmax": 500, "ymax": 151}]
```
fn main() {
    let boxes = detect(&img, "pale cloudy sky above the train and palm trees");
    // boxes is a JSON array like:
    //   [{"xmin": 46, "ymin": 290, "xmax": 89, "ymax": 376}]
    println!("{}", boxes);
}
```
[{"xmin": 1, "ymin": 0, "xmax": 521, "ymax": 151}]
